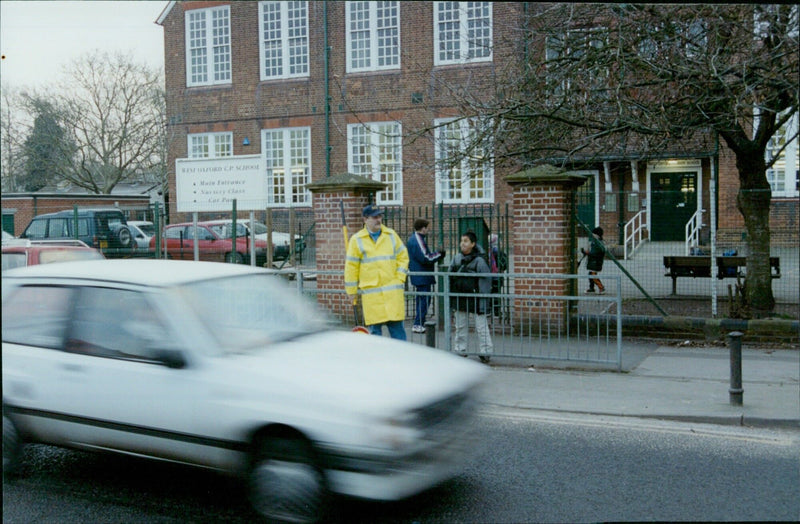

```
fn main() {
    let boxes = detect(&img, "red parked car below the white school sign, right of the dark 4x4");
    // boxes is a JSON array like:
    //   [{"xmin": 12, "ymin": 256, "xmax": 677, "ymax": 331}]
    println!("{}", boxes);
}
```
[{"xmin": 150, "ymin": 222, "xmax": 267, "ymax": 266}]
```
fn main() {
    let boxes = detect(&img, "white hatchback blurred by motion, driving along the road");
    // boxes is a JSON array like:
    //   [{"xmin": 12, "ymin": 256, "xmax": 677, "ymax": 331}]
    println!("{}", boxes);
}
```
[{"xmin": 2, "ymin": 259, "xmax": 488, "ymax": 522}]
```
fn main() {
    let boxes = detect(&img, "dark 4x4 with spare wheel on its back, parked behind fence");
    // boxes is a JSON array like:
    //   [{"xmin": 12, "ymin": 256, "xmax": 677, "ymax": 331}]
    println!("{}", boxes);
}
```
[{"xmin": 20, "ymin": 207, "xmax": 136, "ymax": 258}]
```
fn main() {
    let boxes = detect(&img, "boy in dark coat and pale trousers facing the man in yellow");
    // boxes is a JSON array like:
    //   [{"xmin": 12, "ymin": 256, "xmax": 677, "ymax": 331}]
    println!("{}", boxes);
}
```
[{"xmin": 450, "ymin": 231, "xmax": 494, "ymax": 363}]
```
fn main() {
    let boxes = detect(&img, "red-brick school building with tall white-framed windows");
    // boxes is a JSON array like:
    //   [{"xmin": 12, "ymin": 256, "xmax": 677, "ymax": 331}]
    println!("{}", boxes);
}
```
[{"xmin": 157, "ymin": 1, "xmax": 798, "ymax": 253}]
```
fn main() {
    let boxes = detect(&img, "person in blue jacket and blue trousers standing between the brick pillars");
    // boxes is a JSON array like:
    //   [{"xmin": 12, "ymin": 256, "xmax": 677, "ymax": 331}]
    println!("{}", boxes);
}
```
[{"xmin": 406, "ymin": 218, "xmax": 445, "ymax": 333}]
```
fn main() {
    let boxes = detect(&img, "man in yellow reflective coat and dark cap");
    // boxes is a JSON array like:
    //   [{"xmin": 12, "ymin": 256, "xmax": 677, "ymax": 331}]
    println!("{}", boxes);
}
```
[{"xmin": 344, "ymin": 206, "xmax": 408, "ymax": 340}]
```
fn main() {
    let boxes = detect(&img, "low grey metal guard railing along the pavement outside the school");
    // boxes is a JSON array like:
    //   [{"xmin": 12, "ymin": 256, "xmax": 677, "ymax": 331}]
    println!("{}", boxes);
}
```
[{"xmin": 279, "ymin": 268, "xmax": 622, "ymax": 371}]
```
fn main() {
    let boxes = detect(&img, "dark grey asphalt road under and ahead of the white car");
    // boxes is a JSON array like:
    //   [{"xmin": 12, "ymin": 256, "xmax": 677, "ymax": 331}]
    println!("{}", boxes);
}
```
[{"xmin": 3, "ymin": 410, "xmax": 800, "ymax": 523}]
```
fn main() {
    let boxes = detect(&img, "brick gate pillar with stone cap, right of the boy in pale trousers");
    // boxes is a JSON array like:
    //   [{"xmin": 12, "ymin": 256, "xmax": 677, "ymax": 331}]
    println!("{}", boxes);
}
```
[{"xmin": 506, "ymin": 166, "xmax": 586, "ymax": 330}]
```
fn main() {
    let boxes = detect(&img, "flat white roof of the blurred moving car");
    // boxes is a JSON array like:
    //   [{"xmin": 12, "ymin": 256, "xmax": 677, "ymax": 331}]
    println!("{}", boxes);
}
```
[{"xmin": 3, "ymin": 258, "xmax": 270, "ymax": 287}]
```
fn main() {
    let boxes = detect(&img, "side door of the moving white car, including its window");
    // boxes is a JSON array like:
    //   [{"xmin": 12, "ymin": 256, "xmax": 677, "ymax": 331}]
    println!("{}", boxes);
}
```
[{"xmin": 30, "ymin": 286, "xmax": 206, "ymax": 463}]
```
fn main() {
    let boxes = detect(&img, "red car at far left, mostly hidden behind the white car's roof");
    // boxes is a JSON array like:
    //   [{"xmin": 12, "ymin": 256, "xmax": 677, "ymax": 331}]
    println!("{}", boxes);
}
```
[{"xmin": 2, "ymin": 239, "xmax": 105, "ymax": 271}]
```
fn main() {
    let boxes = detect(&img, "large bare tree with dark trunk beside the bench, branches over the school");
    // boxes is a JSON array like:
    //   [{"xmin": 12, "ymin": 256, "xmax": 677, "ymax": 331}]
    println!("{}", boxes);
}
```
[{"xmin": 437, "ymin": 3, "xmax": 800, "ymax": 315}]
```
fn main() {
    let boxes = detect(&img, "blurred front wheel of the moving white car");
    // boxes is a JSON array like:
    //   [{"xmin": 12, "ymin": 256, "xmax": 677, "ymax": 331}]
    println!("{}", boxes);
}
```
[{"xmin": 250, "ymin": 438, "xmax": 327, "ymax": 522}]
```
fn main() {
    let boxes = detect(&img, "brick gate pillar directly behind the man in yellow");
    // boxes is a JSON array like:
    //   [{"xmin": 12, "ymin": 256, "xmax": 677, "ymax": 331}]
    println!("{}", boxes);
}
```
[{"xmin": 308, "ymin": 174, "xmax": 386, "ymax": 324}]
